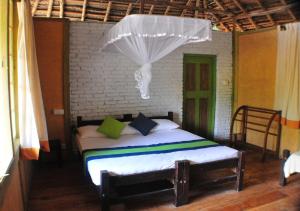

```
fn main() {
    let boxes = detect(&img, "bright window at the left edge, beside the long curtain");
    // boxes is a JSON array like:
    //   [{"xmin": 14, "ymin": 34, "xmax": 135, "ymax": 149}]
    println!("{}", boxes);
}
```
[{"xmin": 0, "ymin": 0, "xmax": 13, "ymax": 182}]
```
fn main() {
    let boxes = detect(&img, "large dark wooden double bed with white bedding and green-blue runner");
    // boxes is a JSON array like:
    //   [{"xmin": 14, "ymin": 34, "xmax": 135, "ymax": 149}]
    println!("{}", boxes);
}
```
[{"xmin": 76, "ymin": 112, "xmax": 245, "ymax": 210}]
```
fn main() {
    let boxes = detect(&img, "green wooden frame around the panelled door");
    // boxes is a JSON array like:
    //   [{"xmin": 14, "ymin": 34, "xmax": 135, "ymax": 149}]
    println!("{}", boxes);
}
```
[{"xmin": 182, "ymin": 53, "xmax": 217, "ymax": 138}]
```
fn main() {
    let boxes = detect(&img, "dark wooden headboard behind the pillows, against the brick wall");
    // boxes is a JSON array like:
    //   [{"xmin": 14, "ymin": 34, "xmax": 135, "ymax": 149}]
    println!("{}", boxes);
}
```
[{"xmin": 77, "ymin": 111, "xmax": 173, "ymax": 127}]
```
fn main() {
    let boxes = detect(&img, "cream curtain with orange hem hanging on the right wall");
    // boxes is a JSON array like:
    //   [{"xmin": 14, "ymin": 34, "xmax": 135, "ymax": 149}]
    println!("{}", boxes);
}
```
[{"xmin": 274, "ymin": 23, "xmax": 300, "ymax": 128}]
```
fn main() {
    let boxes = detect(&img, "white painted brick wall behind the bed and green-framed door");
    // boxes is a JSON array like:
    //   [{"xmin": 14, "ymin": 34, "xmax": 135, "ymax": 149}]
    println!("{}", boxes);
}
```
[{"xmin": 70, "ymin": 22, "xmax": 232, "ymax": 138}]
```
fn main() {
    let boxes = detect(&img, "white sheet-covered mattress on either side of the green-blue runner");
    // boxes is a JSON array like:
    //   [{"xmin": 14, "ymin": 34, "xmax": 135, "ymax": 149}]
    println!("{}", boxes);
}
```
[{"xmin": 76, "ymin": 129, "xmax": 238, "ymax": 185}]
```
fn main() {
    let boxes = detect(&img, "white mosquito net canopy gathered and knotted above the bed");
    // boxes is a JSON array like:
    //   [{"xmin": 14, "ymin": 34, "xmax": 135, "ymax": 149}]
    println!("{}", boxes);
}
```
[{"xmin": 101, "ymin": 15, "xmax": 211, "ymax": 99}]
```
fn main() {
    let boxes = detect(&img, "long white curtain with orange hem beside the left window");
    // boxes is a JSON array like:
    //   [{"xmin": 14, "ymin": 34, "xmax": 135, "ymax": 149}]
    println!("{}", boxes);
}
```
[{"xmin": 18, "ymin": 0, "xmax": 49, "ymax": 160}]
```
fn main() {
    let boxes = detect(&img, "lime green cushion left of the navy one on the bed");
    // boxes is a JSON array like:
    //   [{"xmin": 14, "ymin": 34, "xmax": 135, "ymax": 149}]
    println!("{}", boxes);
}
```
[{"xmin": 97, "ymin": 116, "xmax": 126, "ymax": 139}]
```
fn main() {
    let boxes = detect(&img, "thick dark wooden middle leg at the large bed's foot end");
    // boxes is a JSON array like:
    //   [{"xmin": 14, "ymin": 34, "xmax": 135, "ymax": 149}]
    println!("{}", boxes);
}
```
[{"xmin": 174, "ymin": 160, "xmax": 190, "ymax": 207}]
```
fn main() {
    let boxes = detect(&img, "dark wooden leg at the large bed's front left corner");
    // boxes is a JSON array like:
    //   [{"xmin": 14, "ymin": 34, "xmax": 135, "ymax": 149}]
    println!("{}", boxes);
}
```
[{"xmin": 100, "ymin": 171, "xmax": 109, "ymax": 211}]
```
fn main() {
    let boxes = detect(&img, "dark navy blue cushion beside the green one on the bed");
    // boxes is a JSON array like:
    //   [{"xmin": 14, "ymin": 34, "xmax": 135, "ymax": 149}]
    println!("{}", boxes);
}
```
[{"xmin": 129, "ymin": 113, "xmax": 157, "ymax": 136}]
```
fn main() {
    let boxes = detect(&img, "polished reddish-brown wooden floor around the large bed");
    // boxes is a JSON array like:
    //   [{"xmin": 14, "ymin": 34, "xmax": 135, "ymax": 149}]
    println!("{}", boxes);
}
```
[{"xmin": 28, "ymin": 152, "xmax": 300, "ymax": 211}]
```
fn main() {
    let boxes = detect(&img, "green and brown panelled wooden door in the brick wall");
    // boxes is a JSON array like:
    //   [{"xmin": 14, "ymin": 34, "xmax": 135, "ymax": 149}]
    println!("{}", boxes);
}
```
[{"xmin": 183, "ymin": 54, "xmax": 216, "ymax": 138}]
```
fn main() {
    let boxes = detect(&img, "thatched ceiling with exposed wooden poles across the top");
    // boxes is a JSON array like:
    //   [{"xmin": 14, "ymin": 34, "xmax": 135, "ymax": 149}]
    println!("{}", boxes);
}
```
[{"xmin": 31, "ymin": 0, "xmax": 300, "ymax": 31}]
